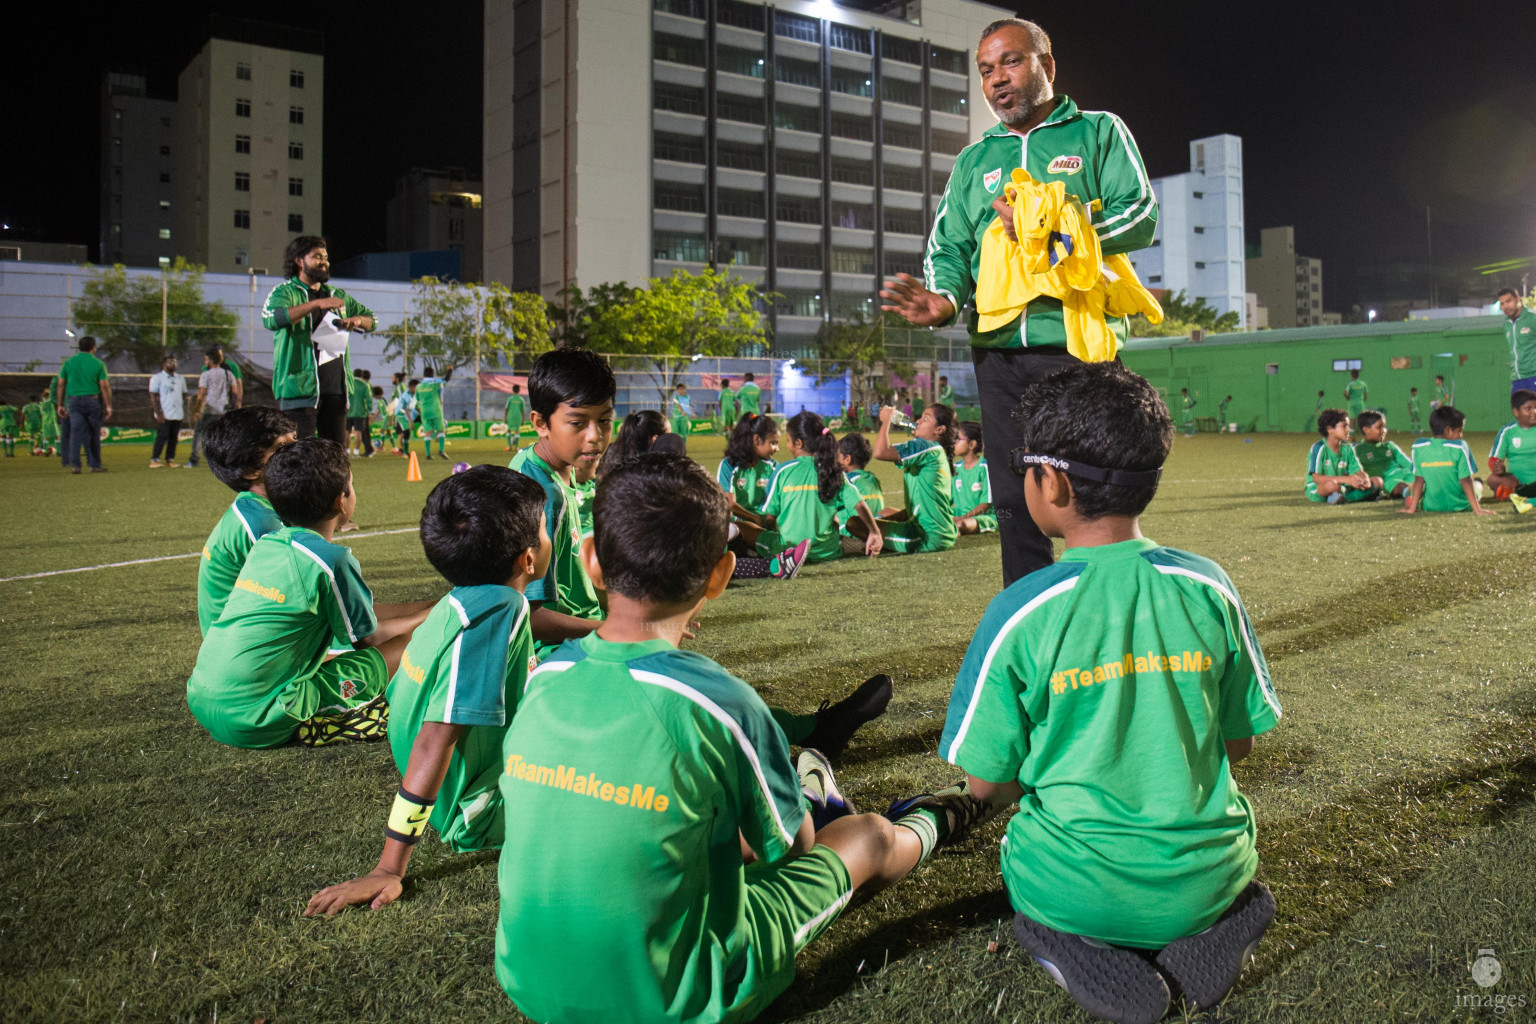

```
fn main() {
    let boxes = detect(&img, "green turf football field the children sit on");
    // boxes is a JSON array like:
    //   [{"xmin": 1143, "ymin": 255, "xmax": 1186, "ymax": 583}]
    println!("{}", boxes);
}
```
[{"xmin": 0, "ymin": 434, "xmax": 1536, "ymax": 1024}]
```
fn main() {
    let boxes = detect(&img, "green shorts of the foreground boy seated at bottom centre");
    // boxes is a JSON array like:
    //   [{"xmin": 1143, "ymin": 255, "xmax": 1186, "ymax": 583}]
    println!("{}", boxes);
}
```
[{"xmin": 720, "ymin": 846, "xmax": 854, "ymax": 1021}]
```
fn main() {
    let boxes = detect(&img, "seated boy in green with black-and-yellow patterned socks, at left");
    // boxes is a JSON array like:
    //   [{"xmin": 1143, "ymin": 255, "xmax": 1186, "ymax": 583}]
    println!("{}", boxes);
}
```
[{"xmin": 187, "ymin": 436, "xmax": 432, "ymax": 748}]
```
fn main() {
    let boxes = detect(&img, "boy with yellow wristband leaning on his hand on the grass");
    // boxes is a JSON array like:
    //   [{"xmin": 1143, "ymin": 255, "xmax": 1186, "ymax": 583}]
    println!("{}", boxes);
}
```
[{"xmin": 304, "ymin": 465, "xmax": 550, "ymax": 917}]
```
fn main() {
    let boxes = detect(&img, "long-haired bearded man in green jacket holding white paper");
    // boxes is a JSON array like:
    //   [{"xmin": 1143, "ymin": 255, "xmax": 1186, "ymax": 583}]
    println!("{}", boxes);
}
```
[{"xmin": 261, "ymin": 235, "xmax": 378, "ymax": 445}]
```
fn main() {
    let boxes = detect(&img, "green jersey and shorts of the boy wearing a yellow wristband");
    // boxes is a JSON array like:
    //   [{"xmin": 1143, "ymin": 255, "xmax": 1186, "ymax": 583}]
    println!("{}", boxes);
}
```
[{"xmin": 386, "ymin": 586, "xmax": 536, "ymax": 854}]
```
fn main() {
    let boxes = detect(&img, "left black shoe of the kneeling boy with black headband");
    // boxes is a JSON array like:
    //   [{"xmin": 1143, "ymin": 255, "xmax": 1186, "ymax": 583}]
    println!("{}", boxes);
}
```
[{"xmin": 1014, "ymin": 913, "xmax": 1172, "ymax": 1024}]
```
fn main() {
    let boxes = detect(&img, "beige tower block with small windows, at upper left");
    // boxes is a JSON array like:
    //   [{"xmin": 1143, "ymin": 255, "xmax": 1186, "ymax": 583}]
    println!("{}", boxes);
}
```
[{"xmin": 170, "ymin": 17, "xmax": 326, "ymax": 273}]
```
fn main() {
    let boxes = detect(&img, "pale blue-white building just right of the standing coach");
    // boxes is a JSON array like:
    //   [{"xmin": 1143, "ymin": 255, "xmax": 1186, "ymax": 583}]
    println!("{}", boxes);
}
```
[{"xmin": 1130, "ymin": 135, "xmax": 1252, "ymax": 325}]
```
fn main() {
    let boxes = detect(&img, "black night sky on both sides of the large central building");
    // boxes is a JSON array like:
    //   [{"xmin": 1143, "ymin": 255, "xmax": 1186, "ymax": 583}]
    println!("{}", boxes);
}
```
[{"xmin": 0, "ymin": 0, "xmax": 1536, "ymax": 312}]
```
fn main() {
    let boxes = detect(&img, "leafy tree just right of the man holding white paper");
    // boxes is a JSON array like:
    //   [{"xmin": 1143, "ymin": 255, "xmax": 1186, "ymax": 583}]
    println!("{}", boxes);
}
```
[{"xmin": 379, "ymin": 278, "xmax": 553, "ymax": 372}]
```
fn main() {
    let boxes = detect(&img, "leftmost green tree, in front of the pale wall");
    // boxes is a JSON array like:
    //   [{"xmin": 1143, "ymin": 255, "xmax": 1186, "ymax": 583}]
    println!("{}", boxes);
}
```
[{"xmin": 69, "ymin": 256, "xmax": 240, "ymax": 372}]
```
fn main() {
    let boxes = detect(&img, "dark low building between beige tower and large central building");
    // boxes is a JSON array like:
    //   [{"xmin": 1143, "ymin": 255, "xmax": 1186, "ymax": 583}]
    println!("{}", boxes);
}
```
[{"xmin": 386, "ymin": 167, "xmax": 484, "ymax": 281}]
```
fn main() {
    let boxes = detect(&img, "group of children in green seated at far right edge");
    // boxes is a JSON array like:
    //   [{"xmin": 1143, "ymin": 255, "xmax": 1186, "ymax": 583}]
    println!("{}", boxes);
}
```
[{"xmin": 1306, "ymin": 388, "xmax": 1536, "ymax": 516}]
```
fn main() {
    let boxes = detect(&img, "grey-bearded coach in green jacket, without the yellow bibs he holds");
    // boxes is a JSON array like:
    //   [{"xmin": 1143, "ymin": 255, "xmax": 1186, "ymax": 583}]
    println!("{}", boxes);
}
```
[{"xmin": 880, "ymin": 18, "xmax": 1157, "ymax": 586}]
